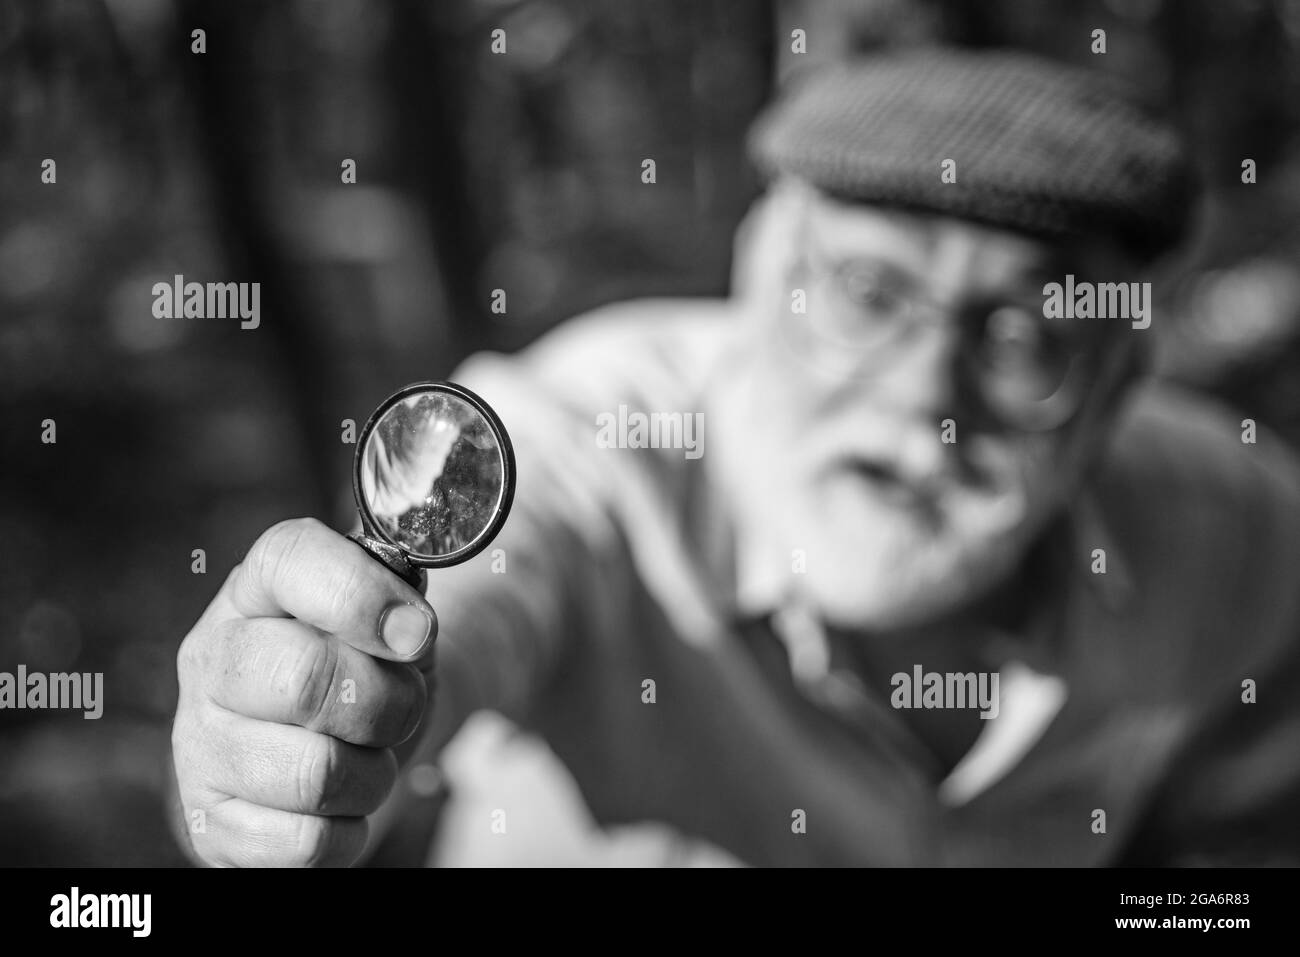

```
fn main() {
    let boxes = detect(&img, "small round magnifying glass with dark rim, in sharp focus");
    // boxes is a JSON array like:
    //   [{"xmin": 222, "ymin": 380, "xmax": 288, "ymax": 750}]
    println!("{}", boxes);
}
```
[{"xmin": 348, "ymin": 382, "xmax": 515, "ymax": 592}]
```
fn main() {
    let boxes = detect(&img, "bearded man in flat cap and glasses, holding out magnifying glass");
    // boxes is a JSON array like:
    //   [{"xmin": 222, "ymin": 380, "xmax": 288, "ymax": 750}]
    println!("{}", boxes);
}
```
[{"xmin": 173, "ymin": 46, "xmax": 1300, "ymax": 865}]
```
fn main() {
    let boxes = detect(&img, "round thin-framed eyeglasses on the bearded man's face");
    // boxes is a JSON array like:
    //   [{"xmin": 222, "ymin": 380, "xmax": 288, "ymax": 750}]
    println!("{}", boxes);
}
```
[{"xmin": 794, "ymin": 242, "xmax": 1092, "ymax": 432}]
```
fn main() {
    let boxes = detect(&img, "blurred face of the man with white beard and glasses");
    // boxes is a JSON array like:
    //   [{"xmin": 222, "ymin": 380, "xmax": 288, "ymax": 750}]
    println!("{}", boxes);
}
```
[{"xmin": 714, "ymin": 184, "xmax": 1141, "ymax": 628}]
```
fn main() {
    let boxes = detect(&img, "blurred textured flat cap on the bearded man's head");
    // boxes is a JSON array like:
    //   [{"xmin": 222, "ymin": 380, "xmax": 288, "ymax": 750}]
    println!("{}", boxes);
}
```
[{"xmin": 749, "ymin": 48, "xmax": 1196, "ymax": 257}]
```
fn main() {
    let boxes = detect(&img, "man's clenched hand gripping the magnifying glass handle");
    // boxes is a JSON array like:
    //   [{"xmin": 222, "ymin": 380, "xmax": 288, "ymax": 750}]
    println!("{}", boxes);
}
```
[{"xmin": 172, "ymin": 519, "xmax": 438, "ymax": 866}]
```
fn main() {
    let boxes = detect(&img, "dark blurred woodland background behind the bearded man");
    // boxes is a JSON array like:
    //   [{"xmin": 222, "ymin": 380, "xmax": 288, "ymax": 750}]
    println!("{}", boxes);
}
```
[{"xmin": 0, "ymin": 0, "xmax": 1300, "ymax": 865}]
